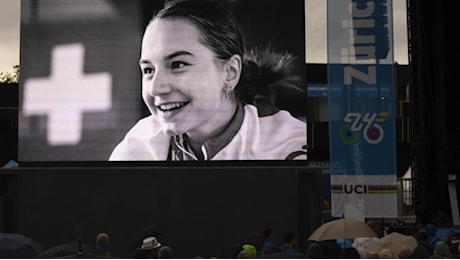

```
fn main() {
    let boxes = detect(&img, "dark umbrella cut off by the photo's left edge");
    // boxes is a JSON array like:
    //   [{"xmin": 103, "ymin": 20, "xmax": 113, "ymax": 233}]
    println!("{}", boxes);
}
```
[{"xmin": 0, "ymin": 233, "xmax": 43, "ymax": 259}]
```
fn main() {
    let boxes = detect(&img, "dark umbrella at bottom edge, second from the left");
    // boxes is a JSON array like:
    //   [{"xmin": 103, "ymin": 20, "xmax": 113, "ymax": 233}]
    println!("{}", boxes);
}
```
[{"xmin": 37, "ymin": 240, "xmax": 104, "ymax": 258}]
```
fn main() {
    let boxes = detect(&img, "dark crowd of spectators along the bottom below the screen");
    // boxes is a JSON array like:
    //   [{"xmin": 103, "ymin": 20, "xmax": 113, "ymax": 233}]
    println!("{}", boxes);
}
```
[{"xmin": 0, "ymin": 222, "xmax": 460, "ymax": 259}]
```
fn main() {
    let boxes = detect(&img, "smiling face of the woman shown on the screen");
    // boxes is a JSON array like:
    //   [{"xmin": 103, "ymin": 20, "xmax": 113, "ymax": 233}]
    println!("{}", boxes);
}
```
[{"xmin": 140, "ymin": 19, "xmax": 231, "ymax": 136}]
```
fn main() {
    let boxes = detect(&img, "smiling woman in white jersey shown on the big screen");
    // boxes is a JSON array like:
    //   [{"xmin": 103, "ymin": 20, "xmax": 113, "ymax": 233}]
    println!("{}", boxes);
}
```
[{"xmin": 109, "ymin": 0, "xmax": 307, "ymax": 161}]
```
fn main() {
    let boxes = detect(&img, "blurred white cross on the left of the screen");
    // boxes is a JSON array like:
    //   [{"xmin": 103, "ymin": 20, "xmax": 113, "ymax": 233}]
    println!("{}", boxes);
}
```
[{"xmin": 22, "ymin": 44, "xmax": 112, "ymax": 145}]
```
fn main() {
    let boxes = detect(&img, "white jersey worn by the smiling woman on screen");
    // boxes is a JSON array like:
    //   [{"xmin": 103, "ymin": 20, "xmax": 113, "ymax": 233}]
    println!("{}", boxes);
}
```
[{"xmin": 109, "ymin": 105, "xmax": 307, "ymax": 161}]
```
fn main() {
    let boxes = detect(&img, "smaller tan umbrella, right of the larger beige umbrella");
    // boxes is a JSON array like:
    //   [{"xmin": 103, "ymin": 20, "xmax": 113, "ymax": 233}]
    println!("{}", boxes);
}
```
[{"xmin": 369, "ymin": 232, "xmax": 417, "ymax": 256}]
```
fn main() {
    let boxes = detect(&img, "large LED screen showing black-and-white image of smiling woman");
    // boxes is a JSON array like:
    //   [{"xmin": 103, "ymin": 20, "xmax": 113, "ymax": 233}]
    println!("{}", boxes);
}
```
[{"xmin": 18, "ymin": 0, "xmax": 307, "ymax": 164}]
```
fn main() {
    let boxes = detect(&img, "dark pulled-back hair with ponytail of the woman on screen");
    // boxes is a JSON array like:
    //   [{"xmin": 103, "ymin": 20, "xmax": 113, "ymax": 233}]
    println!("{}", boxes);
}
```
[{"xmin": 151, "ymin": 0, "xmax": 304, "ymax": 111}]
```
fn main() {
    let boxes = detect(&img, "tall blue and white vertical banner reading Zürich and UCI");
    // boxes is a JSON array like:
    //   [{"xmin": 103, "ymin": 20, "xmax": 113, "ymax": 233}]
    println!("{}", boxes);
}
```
[{"xmin": 327, "ymin": 0, "xmax": 397, "ymax": 218}]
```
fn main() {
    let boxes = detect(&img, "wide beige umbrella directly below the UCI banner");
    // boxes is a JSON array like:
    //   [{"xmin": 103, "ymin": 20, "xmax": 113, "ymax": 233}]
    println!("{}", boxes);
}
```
[{"xmin": 308, "ymin": 218, "xmax": 377, "ymax": 241}]
